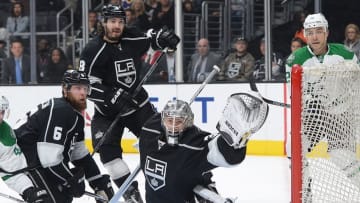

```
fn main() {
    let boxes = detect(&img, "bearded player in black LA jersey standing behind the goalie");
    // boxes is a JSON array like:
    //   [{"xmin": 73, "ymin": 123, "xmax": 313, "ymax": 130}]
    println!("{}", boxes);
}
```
[{"xmin": 79, "ymin": 4, "xmax": 180, "ymax": 202}]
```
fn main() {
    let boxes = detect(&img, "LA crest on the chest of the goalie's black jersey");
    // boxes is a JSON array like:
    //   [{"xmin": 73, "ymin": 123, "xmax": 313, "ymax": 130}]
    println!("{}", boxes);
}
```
[{"xmin": 144, "ymin": 156, "xmax": 167, "ymax": 191}]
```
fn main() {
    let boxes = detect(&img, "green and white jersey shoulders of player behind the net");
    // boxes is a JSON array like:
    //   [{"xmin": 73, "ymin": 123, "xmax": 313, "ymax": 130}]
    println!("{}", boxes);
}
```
[{"xmin": 286, "ymin": 43, "xmax": 358, "ymax": 82}]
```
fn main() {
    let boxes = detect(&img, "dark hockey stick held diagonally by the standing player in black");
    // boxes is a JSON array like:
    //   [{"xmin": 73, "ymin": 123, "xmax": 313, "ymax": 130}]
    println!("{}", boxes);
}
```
[{"xmin": 91, "ymin": 49, "xmax": 167, "ymax": 156}]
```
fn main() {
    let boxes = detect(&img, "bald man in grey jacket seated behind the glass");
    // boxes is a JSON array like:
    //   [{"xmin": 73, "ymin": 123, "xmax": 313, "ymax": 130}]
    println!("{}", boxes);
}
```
[{"xmin": 187, "ymin": 38, "xmax": 222, "ymax": 82}]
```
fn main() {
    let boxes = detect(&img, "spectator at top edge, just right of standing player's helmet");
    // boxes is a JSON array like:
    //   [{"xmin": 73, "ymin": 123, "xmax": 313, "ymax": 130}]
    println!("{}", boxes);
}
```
[{"xmin": 131, "ymin": 0, "xmax": 150, "ymax": 31}]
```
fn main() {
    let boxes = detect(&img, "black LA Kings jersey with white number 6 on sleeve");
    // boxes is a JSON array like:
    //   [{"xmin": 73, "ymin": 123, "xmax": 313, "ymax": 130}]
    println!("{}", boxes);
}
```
[{"xmin": 15, "ymin": 98, "xmax": 89, "ymax": 184}]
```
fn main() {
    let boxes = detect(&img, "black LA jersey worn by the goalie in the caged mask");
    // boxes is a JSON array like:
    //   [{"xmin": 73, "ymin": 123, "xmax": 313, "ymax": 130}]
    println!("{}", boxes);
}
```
[{"xmin": 139, "ymin": 114, "xmax": 246, "ymax": 203}]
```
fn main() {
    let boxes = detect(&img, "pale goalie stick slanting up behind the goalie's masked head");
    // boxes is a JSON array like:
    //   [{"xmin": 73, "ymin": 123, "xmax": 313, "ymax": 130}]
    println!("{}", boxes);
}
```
[{"xmin": 109, "ymin": 65, "xmax": 220, "ymax": 203}]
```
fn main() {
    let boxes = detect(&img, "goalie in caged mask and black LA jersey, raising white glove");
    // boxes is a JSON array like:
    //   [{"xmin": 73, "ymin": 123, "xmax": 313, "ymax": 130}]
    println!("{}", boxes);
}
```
[{"xmin": 139, "ymin": 93, "xmax": 268, "ymax": 203}]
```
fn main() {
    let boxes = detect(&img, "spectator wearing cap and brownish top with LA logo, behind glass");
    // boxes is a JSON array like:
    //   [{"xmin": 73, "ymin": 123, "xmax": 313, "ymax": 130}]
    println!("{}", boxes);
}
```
[{"xmin": 217, "ymin": 37, "xmax": 255, "ymax": 81}]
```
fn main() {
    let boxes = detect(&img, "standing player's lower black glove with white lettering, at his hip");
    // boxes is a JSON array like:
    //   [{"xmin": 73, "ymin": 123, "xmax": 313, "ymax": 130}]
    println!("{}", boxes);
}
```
[{"xmin": 106, "ymin": 88, "xmax": 139, "ymax": 114}]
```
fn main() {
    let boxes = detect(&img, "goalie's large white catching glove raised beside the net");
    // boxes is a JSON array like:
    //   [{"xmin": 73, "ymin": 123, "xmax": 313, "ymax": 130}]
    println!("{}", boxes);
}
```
[{"xmin": 216, "ymin": 91, "xmax": 269, "ymax": 148}]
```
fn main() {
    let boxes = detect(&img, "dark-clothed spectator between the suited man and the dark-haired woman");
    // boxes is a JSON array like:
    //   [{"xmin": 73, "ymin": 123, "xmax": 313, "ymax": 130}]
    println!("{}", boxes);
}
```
[{"xmin": 36, "ymin": 38, "xmax": 50, "ymax": 82}]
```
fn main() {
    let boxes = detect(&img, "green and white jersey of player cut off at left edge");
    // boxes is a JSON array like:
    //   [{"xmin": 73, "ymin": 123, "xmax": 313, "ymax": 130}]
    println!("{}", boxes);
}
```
[{"xmin": 0, "ymin": 121, "xmax": 33, "ymax": 194}]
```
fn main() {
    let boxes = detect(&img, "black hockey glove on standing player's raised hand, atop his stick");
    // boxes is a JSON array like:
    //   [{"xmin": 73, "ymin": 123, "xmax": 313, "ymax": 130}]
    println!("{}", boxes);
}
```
[{"xmin": 156, "ymin": 26, "xmax": 180, "ymax": 50}]
